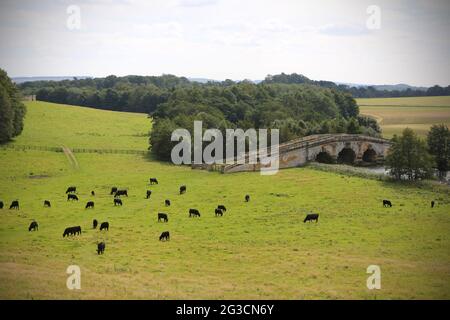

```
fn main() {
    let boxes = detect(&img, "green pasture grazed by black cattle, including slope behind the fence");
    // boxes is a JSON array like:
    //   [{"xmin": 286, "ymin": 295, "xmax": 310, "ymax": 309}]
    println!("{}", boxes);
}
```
[{"xmin": 0, "ymin": 103, "xmax": 450, "ymax": 299}]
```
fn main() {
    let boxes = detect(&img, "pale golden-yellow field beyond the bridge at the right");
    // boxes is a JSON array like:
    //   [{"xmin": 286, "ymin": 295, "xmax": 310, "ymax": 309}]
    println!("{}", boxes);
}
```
[{"xmin": 356, "ymin": 96, "xmax": 450, "ymax": 138}]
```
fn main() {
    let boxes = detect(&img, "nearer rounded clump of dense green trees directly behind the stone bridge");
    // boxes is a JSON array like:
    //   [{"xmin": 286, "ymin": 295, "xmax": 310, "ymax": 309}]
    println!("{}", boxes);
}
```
[{"xmin": 150, "ymin": 82, "xmax": 381, "ymax": 160}]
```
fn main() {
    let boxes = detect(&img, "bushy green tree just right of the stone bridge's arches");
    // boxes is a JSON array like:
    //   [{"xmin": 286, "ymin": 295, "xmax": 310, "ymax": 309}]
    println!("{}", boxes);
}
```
[{"xmin": 386, "ymin": 128, "xmax": 433, "ymax": 180}]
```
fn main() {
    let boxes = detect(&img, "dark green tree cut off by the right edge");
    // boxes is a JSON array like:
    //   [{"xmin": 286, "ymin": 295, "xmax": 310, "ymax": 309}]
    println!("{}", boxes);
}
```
[{"xmin": 427, "ymin": 124, "xmax": 450, "ymax": 178}]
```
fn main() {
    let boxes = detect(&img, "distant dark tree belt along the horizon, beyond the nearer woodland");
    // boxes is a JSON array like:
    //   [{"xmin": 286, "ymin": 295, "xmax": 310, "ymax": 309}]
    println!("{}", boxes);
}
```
[{"xmin": 19, "ymin": 73, "xmax": 450, "ymax": 113}]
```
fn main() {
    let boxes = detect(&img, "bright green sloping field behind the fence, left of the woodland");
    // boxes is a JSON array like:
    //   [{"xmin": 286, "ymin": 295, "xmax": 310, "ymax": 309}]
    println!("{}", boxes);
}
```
[{"xmin": 10, "ymin": 102, "xmax": 151, "ymax": 150}]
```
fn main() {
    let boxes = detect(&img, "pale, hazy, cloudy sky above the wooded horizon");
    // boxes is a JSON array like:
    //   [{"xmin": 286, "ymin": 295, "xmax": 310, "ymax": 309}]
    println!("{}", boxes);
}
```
[{"xmin": 0, "ymin": 0, "xmax": 450, "ymax": 86}]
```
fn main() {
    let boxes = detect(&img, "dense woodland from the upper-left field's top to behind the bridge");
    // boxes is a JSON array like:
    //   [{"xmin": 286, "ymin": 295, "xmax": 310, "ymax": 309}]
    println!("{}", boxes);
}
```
[{"xmin": 15, "ymin": 75, "xmax": 380, "ymax": 160}]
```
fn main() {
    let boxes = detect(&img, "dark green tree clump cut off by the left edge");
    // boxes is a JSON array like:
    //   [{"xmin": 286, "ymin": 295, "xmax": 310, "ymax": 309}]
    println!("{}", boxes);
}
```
[{"xmin": 0, "ymin": 69, "xmax": 26, "ymax": 143}]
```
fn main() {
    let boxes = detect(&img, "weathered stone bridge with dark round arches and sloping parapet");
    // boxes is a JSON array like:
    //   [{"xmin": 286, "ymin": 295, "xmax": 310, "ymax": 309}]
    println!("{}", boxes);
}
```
[{"xmin": 193, "ymin": 134, "xmax": 391, "ymax": 173}]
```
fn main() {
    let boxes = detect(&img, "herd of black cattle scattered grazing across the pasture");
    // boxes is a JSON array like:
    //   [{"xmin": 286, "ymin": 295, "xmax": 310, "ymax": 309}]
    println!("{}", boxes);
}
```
[{"xmin": 0, "ymin": 178, "xmax": 435, "ymax": 254}]
